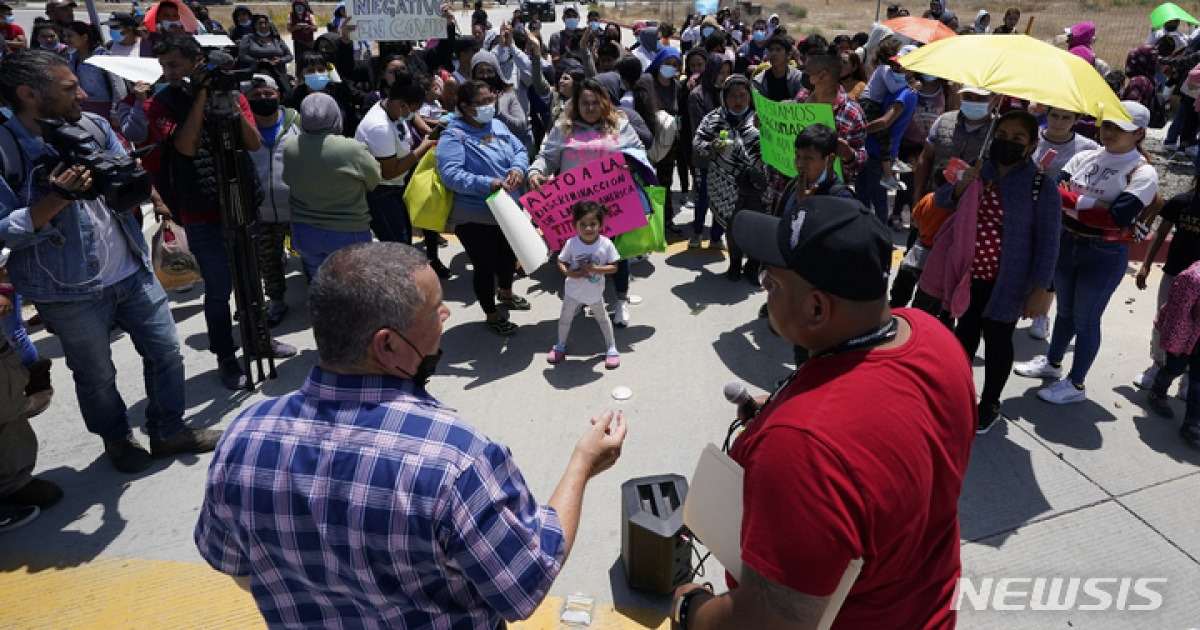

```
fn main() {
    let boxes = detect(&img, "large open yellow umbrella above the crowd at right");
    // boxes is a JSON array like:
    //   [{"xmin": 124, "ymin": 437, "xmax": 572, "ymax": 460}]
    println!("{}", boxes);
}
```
[{"xmin": 899, "ymin": 35, "xmax": 1129, "ymax": 121}]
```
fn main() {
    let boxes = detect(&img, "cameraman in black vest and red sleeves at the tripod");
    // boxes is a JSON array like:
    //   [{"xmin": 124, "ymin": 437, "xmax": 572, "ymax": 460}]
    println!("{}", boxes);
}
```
[{"xmin": 145, "ymin": 35, "xmax": 296, "ymax": 390}]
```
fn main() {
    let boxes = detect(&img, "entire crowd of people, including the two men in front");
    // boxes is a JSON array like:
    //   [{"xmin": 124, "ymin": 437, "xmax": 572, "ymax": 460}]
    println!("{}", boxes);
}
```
[{"xmin": 0, "ymin": 0, "xmax": 1200, "ymax": 628}]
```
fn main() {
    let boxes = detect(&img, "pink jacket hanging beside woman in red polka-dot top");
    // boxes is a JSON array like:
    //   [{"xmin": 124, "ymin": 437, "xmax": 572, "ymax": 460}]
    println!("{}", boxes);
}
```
[{"xmin": 920, "ymin": 179, "xmax": 983, "ymax": 318}]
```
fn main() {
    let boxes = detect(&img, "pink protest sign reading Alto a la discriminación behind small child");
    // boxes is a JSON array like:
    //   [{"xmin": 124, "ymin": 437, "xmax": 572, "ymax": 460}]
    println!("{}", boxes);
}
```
[{"xmin": 521, "ymin": 154, "xmax": 646, "ymax": 252}]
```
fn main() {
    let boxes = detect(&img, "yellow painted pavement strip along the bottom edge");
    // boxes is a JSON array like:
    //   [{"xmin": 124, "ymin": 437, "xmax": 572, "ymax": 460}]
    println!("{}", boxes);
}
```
[{"xmin": 0, "ymin": 554, "xmax": 670, "ymax": 630}]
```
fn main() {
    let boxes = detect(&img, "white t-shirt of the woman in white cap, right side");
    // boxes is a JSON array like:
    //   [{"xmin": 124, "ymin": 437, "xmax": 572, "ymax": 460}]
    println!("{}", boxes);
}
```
[{"xmin": 1062, "ymin": 149, "xmax": 1158, "ymax": 210}]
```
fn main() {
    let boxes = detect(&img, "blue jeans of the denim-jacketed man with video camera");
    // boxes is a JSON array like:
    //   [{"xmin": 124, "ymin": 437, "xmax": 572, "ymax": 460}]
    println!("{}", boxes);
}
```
[{"xmin": 37, "ymin": 269, "xmax": 186, "ymax": 442}]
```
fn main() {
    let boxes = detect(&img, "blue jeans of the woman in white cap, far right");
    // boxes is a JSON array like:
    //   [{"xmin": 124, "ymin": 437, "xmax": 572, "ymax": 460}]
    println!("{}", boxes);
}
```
[{"xmin": 1046, "ymin": 230, "xmax": 1129, "ymax": 384}]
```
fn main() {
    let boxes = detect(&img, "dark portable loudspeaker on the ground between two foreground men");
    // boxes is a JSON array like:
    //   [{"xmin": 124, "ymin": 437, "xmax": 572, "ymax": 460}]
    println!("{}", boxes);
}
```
[{"xmin": 620, "ymin": 475, "xmax": 691, "ymax": 595}]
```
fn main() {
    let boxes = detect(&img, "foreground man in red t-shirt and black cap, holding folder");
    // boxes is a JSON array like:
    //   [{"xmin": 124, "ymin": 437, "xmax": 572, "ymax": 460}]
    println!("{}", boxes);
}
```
[{"xmin": 672, "ymin": 197, "xmax": 977, "ymax": 630}]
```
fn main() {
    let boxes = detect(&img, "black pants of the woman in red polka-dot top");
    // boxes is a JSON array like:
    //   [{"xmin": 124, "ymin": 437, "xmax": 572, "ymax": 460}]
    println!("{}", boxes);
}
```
[{"xmin": 954, "ymin": 280, "xmax": 1016, "ymax": 404}]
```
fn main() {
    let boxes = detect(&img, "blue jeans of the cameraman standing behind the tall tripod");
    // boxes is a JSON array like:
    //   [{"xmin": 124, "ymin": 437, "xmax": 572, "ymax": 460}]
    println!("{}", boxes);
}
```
[{"xmin": 184, "ymin": 221, "xmax": 238, "ymax": 359}]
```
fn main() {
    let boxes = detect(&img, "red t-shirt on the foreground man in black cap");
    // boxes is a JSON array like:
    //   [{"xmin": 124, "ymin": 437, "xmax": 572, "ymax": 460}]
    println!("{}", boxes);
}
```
[{"xmin": 731, "ymin": 308, "xmax": 977, "ymax": 629}]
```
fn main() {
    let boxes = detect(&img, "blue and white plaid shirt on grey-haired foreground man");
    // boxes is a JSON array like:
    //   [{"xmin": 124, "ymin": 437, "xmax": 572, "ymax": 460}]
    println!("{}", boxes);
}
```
[{"xmin": 194, "ymin": 367, "xmax": 565, "ymax": 630}]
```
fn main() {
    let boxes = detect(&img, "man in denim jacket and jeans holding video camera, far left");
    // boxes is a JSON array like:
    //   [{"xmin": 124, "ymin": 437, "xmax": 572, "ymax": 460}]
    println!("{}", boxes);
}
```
[{"xmin": 0, "ymin": 50, "xmax": 220, "ymax": 473}]
